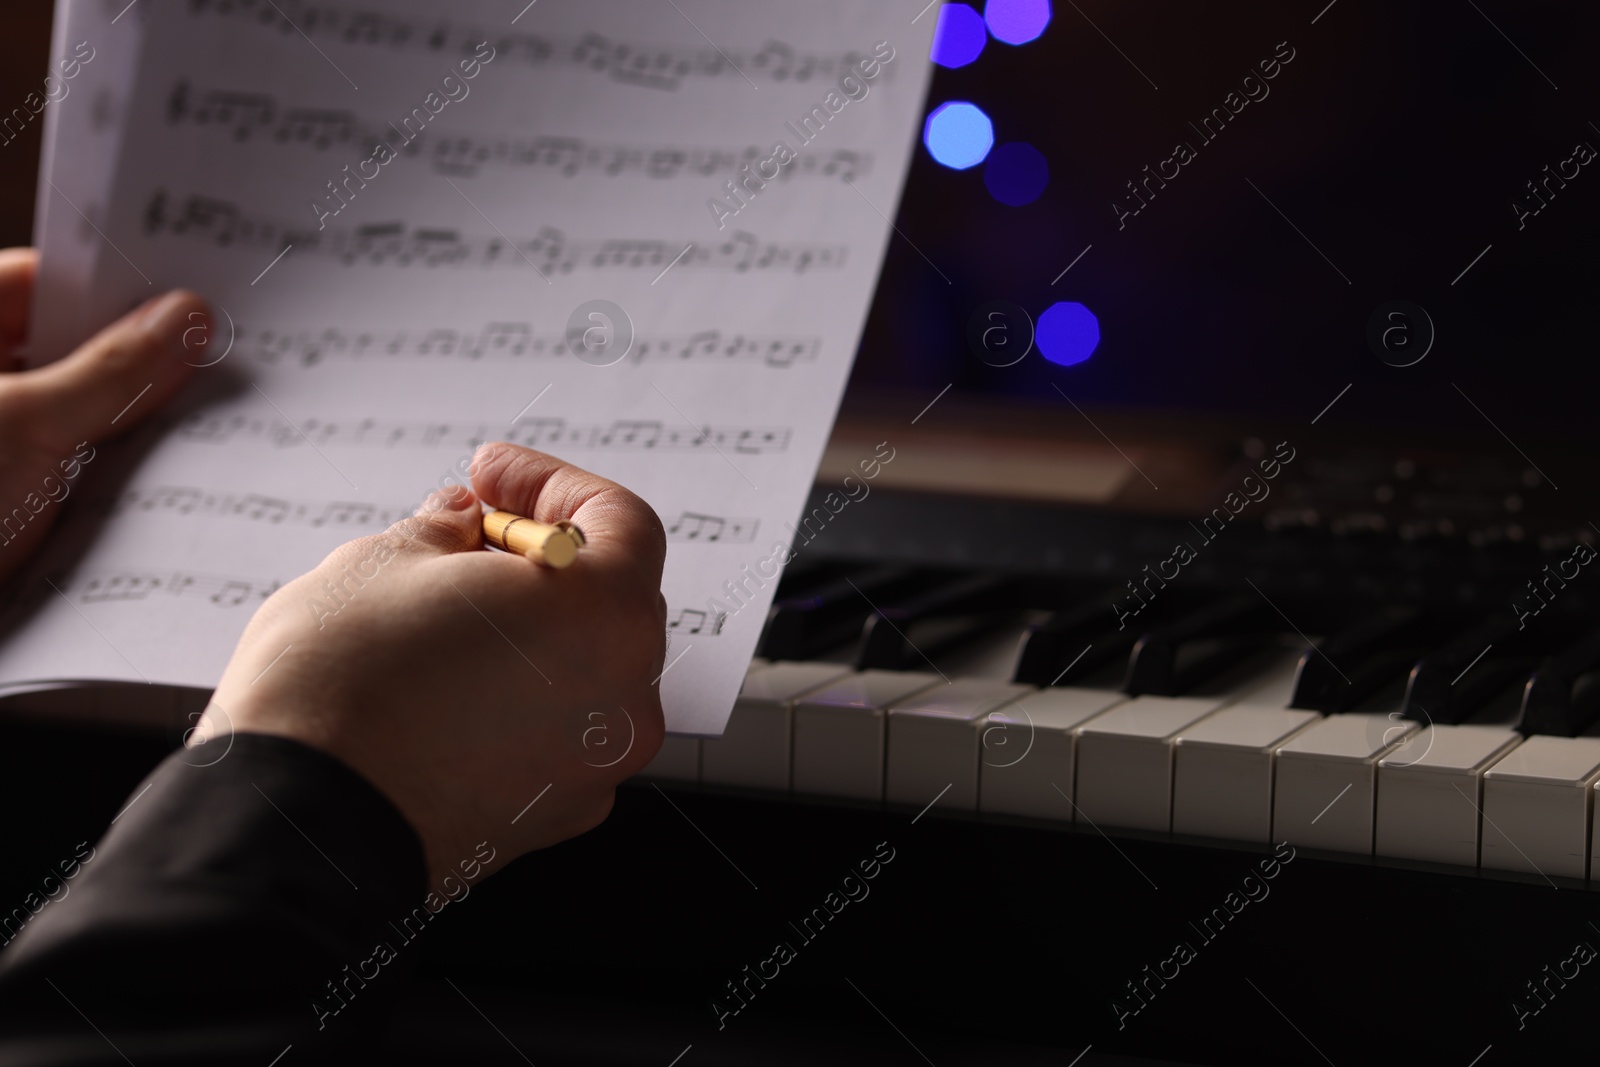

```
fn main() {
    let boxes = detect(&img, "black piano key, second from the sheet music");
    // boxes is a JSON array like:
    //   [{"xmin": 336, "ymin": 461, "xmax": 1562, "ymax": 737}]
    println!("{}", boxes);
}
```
[{"xmin": 856, "ymin": 574, "xmax": 1016, "ymax": 670}]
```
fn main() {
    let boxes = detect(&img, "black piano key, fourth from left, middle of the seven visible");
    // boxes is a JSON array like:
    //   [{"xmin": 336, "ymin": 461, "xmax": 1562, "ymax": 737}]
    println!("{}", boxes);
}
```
[{"xmin": 1122, "ymin": 593, "xmax": 1283, "ymax": 696}]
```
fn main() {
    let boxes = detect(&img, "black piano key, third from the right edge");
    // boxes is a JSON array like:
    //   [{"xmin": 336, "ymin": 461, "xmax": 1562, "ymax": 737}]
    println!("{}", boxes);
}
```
[{"xmin": 1290, "ymin": 606, "xmax": 1442, "ymax": 715}]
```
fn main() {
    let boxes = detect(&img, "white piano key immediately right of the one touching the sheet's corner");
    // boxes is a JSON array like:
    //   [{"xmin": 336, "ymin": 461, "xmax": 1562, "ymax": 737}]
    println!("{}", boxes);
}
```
[{"xmin": 794, "ymin": 670, "xmax": 944, "ymax": 801}]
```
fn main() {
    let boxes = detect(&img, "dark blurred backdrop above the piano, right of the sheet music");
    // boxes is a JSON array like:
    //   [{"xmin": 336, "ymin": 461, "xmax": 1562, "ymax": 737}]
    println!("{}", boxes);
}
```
[{"xmin": 853, "ymin": 0, "xmax": 1600, "ymax": 451}]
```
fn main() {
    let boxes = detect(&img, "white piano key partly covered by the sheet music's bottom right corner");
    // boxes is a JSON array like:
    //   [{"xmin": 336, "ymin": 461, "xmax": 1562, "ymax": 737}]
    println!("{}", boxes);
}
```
[{"xmin": 701, "ymin": 662, "xmax": 850, "ymax": 792}]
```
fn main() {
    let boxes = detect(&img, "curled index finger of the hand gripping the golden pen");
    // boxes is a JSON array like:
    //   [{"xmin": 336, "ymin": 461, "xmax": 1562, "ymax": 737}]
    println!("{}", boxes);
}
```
[{"xmin": 472, "ymin": 442, "xmax": 667, "ymax": 585}]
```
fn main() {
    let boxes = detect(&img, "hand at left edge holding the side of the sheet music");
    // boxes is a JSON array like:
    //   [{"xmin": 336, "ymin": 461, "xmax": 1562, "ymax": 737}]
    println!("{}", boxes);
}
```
[{"xmin": 0, "ymin": 248, "xmax": 211, "ymax": 579}]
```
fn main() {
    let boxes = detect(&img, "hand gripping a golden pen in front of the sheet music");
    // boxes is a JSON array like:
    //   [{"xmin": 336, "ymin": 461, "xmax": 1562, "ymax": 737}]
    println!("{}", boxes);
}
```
[{"xmin": 197, "ymin": 443, "xmax": 667, "ymax": 888}]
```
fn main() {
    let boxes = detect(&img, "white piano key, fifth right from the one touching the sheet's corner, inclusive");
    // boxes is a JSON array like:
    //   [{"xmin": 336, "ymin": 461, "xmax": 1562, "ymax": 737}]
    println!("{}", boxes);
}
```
[{"xmin": 1074, "ymin": 696, "xmax": 1221, "ymax": 832}]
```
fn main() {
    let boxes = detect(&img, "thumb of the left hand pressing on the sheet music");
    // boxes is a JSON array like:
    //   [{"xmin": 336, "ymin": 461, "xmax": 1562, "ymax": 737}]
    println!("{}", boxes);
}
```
[{"xmin": 5, "ymin": 290, "xmax": 211, "ymax": 451}]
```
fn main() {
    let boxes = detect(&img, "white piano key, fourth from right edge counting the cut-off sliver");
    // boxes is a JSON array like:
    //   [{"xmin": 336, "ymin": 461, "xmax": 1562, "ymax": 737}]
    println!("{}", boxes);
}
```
[{"xmin": 1272, "ymin": 713, "xmax": 1418, "ymax": 856}]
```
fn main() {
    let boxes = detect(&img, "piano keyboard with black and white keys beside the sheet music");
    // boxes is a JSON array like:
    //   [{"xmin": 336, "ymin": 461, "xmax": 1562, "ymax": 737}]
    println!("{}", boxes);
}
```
[{"xmin": 646, "ymin": 441, "xmax": 1600, "ymax": 889}]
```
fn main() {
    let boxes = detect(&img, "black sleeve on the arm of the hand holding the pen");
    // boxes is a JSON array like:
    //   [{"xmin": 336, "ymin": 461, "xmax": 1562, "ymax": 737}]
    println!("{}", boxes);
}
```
[{"xmin": 0, "ymin": 734, "xmax": 430, "ymax": 1067}]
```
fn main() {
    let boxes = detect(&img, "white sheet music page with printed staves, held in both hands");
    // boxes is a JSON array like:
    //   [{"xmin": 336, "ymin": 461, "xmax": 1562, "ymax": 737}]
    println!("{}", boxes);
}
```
[{"xmin": 0, "ymin": 0, "xmax": 934, "ymax": 734}]
